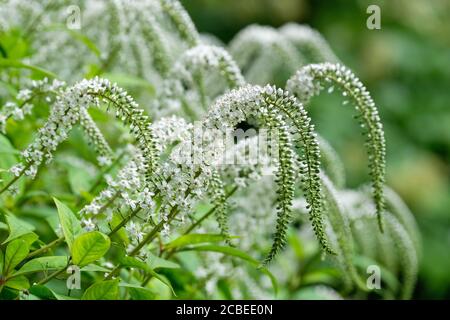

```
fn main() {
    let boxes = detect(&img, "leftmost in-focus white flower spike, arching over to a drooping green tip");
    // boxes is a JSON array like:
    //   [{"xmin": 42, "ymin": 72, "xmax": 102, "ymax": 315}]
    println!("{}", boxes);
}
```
[{"xmin": 5, "ymin": 78, "xmax": 157, "ymax": 191}]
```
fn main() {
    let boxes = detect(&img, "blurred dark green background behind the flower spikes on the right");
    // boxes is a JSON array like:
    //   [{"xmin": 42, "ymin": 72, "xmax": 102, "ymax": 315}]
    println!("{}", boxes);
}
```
[{"xmin": 182, "ymin": 0, "xmax": 450, "ymax": 299}]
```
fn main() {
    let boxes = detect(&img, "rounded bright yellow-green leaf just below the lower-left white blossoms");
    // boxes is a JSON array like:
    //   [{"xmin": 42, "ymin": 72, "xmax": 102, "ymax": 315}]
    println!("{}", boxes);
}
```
[{"xmin": 72, "ymin": 231, "xmax": 111, "ymax": 267}]
